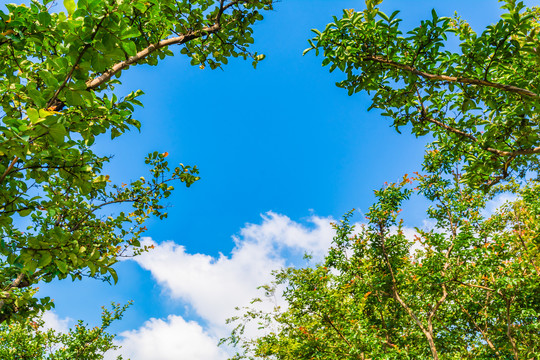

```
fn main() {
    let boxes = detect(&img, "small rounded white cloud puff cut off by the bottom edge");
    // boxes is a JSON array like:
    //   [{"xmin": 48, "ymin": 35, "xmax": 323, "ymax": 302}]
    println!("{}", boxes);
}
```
[{"xmin": 107, "ymin": 315, "xmax": 227, "ymax": 360}]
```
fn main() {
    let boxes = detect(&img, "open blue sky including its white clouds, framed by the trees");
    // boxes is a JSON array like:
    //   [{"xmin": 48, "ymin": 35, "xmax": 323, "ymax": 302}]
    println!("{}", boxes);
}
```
[{"xmin": 4, "ymin": 0, "xmax": 534, "ymax": 359}]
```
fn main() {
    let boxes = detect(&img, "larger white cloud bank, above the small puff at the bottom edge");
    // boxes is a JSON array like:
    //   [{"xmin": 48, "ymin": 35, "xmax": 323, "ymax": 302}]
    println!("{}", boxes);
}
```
[{"xmin": 135, "ymin": 212, "xmax": 334, "ymax": 328}]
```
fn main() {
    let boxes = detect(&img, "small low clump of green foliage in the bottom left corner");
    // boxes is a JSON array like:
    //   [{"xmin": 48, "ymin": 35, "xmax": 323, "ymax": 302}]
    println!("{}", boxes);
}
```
[{"xmin": 0, "ymin": 303, "xmax": 130, "ymax": 360}]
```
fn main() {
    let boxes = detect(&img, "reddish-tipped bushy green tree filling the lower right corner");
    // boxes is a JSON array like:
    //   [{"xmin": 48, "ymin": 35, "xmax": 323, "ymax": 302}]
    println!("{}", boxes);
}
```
[{"xmin": 227, "ymin": 175, "xmax": 540, "ymax": 360}]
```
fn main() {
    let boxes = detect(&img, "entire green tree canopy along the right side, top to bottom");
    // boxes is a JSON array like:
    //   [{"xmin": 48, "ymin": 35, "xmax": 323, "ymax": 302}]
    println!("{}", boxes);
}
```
[{"xmin": 222, "ymin": 0, "xmax": 540, "ymax": 360}]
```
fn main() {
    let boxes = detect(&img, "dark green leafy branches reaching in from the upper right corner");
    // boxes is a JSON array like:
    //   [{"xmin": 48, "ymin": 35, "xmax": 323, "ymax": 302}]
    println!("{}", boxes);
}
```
[{"xmin": 306, "ymin": 0, "xmax": 540, "ymax": 186}]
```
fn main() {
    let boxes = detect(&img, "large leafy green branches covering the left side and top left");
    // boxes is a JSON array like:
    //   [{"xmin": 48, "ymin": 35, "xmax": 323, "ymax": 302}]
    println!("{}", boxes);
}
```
[{"xmin": 0, "ymin": 0, "xmax": 273, "ymax": 323}]
